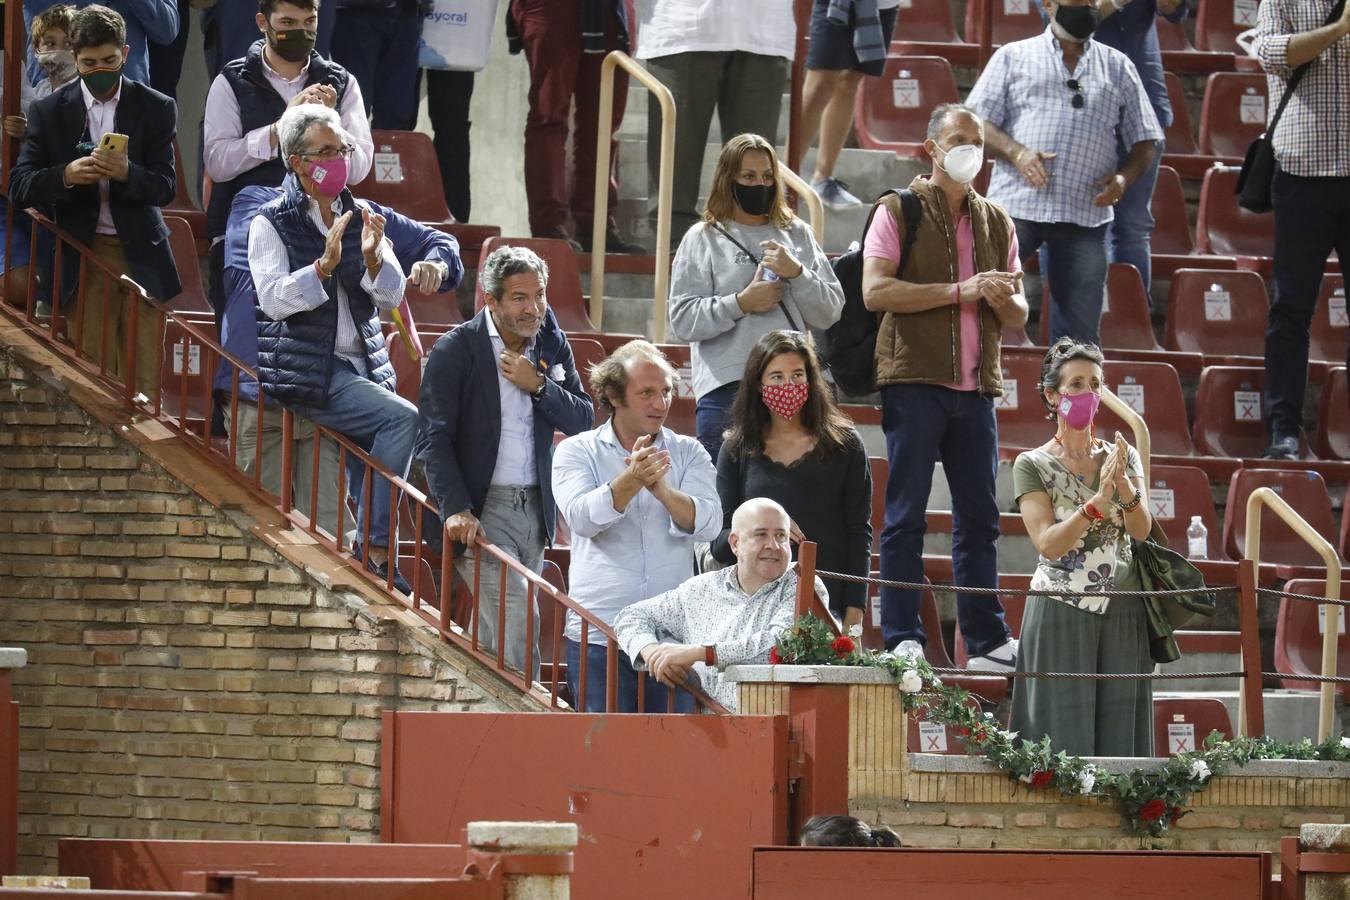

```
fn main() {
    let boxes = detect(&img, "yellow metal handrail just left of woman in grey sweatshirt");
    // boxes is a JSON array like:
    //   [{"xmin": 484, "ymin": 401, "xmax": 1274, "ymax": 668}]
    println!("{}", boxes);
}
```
[{"xmin": 590, "ymin": 50, "xmax": 675, "ymax": 343}]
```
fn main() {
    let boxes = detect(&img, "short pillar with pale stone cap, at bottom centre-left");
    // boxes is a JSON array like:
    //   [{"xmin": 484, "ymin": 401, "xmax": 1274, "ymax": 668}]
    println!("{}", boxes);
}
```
[{"xmin": 466, "ymin": 822, "xmax": 576, "ymax": 900}]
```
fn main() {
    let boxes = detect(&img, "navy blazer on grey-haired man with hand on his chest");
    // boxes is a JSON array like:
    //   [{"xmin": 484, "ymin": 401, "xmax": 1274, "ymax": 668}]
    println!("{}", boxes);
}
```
[{"xmin": 417, "ymin": 306, "xmax": 594, "ymax": 555}]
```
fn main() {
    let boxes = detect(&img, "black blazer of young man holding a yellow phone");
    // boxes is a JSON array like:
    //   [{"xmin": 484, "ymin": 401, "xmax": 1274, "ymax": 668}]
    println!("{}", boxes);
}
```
[{"xmin": 9, "ymin": 78, "xmax": 182, "ymax": 302}]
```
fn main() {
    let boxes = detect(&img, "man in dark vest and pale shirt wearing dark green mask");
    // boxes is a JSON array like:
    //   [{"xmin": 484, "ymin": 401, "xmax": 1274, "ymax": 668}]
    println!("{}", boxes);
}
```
[{"xmin": 203, "ymin": 0, "xmax": 374, "ymax": 330}]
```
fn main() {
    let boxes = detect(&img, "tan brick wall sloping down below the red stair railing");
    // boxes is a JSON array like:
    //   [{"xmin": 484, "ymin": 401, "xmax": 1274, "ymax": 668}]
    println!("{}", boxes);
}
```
[{"xmin": 0, "ymin": 342, "xmax": 518, "ymax": 873}]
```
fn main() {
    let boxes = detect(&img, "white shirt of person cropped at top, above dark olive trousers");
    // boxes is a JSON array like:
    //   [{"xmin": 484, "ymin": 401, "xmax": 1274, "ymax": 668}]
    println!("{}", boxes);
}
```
[{"xmin": 637, "ymin": 0, "xmax": 797, "ymax": 59}]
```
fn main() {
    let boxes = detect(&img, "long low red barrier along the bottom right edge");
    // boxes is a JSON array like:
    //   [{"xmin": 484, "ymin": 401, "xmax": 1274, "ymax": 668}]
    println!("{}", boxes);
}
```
[{"xmin": 745, "ymin": 847, "xmax": 1270, "ymax": 900}]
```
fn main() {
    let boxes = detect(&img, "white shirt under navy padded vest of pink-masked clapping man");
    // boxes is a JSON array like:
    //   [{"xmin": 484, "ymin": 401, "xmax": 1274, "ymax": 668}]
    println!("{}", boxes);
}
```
[{"xmin": 248, "ymin": 200, "xmax": 404, "ymax": 375}]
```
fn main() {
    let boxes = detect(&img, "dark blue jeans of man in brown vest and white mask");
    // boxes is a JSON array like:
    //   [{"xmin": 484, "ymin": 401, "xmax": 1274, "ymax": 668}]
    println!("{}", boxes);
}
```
[{"xmin": 882, "ymin": 385, "xmax": 1008, "ymax": 656}]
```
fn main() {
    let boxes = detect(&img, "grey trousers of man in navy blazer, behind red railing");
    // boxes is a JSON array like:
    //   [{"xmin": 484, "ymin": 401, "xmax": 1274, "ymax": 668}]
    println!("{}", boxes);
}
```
[{"xmin": 455, "ymin": 484, "xmax": 544, "ymax": 681}]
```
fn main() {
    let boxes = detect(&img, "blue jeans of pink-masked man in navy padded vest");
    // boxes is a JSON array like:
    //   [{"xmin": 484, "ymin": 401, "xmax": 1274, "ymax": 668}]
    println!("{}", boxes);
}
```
[{"xmin": 292, "ymin": 358, "xmax": 417, "ymax": 546}]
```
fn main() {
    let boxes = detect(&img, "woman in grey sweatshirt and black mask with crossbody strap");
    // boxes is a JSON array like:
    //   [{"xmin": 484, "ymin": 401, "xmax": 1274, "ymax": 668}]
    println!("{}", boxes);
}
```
[{"xmin": 670, "ymin": 135, "xmax": 844, "ymax": 469}]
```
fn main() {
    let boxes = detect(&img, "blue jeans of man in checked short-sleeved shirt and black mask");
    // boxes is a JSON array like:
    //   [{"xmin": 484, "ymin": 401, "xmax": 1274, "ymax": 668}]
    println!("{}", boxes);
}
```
[{"xmin": 1013, "ymin": 219, "xmax": 1107, "ymax": 344}]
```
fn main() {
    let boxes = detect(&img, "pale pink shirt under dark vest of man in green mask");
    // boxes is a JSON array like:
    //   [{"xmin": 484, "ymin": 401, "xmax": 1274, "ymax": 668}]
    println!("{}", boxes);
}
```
[{"xmin": 203, "ymin": 55, "xmax": 375, "ymax": 185}]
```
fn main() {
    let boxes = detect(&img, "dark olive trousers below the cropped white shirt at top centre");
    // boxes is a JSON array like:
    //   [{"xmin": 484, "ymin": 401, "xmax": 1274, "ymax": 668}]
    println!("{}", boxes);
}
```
[{"xmin": 647, "ymin": 51, "xmax": 788, "ymax": 246}]
